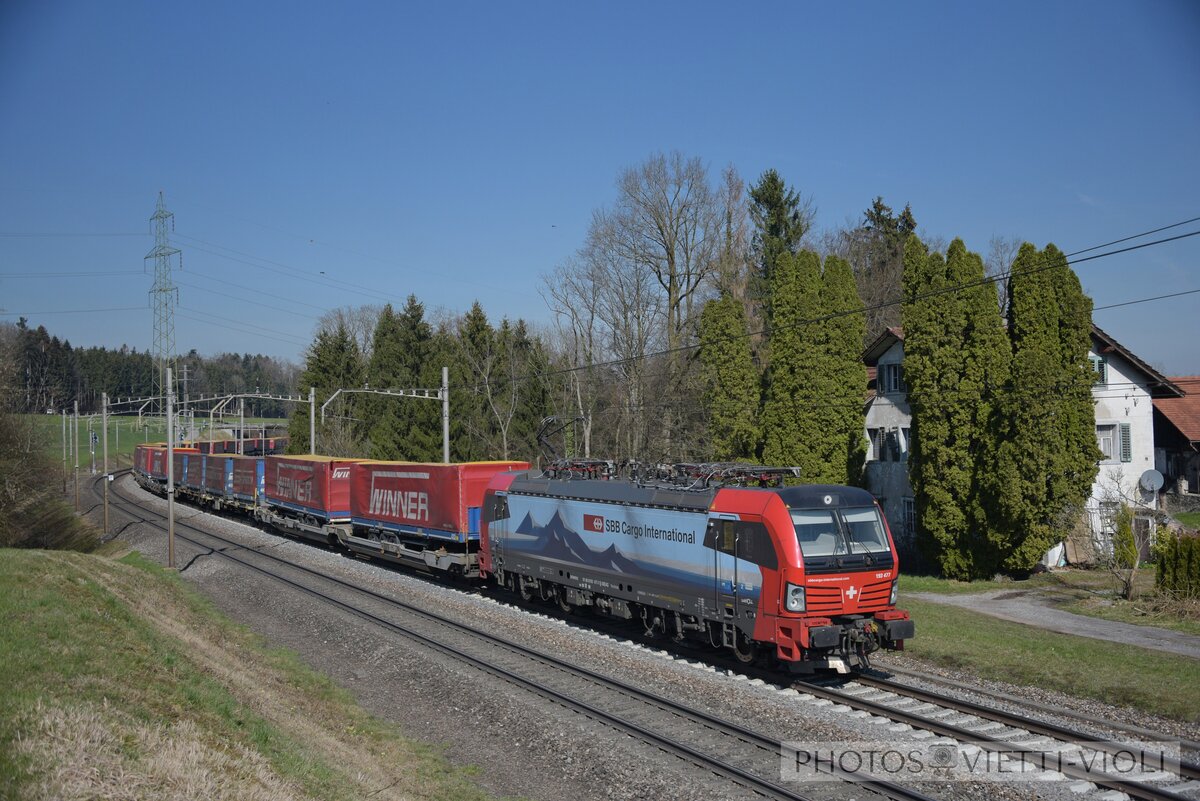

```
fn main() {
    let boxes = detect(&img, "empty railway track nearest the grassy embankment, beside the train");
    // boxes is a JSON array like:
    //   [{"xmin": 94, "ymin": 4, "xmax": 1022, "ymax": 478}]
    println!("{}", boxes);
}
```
[{"xmin": 113, "ymin": 474, "xmax": 929, "ymax": 801}]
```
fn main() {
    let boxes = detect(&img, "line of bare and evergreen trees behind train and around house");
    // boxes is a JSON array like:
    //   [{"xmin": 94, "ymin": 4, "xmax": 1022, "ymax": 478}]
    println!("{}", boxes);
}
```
[{"xmin": 290, "ymin": 153, "xmax": 1097, "ymax": 578}]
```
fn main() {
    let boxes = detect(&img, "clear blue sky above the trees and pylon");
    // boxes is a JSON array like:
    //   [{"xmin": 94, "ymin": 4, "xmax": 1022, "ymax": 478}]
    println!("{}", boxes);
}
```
[{"xmin": 0, "ymin": 0, "xmax": 1200, "ymax": 374}]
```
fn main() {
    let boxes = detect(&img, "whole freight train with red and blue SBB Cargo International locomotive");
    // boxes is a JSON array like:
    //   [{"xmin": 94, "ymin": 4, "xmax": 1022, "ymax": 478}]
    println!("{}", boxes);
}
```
[{"xmin": 134, "ymin": 445, "xmax": 914, "ymax": 673}]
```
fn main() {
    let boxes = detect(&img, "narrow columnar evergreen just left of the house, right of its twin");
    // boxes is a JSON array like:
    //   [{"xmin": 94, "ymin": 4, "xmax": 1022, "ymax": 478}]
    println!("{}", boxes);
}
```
[{"xmin": 820, "ymin": 257, "xmax": 866, "ymax": 484}]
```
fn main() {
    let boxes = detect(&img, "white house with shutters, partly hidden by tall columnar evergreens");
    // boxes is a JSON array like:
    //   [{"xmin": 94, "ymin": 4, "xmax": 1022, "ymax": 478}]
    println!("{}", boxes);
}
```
[{"xmin": 863, "ymin": 324, "xmax": 1183, "ymax": 558}]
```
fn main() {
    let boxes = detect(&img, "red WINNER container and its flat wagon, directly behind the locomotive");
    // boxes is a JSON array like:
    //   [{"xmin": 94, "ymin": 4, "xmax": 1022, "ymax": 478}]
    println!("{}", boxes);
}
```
[{"xmin": 342, "ymin": 462, "xmax": 529, "ymax": 576}]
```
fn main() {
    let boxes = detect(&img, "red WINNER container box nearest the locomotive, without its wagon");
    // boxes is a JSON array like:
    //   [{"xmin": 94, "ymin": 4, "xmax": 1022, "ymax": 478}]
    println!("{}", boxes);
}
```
[{"xmin": 350, "ymin": 462, "xmax": 529, "ymax": 534}]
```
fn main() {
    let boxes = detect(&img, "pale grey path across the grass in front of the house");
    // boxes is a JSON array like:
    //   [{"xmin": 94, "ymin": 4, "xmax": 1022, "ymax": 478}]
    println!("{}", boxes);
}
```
[{"xmin": 905, "ymin": 590, "xmax": 1200, "ymax": 660}]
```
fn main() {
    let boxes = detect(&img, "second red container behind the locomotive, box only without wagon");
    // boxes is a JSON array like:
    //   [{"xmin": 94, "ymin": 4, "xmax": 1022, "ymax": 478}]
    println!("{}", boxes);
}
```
[{"xmin": 264, "ymin": 456, "xmax": 354, "ymax": 520}]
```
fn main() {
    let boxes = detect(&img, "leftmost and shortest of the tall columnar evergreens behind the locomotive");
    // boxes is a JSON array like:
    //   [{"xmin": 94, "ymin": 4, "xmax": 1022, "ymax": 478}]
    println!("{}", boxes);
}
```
[{"xmin": 700, "ymin": 294, "xmax": 758, "ymax": 462}]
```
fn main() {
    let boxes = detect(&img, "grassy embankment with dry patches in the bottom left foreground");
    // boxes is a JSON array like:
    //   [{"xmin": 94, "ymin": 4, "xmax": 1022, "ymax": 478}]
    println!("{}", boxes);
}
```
[{"xmin": 0, "ymin": 549, "xmax": 486, "ymax": 800}]
